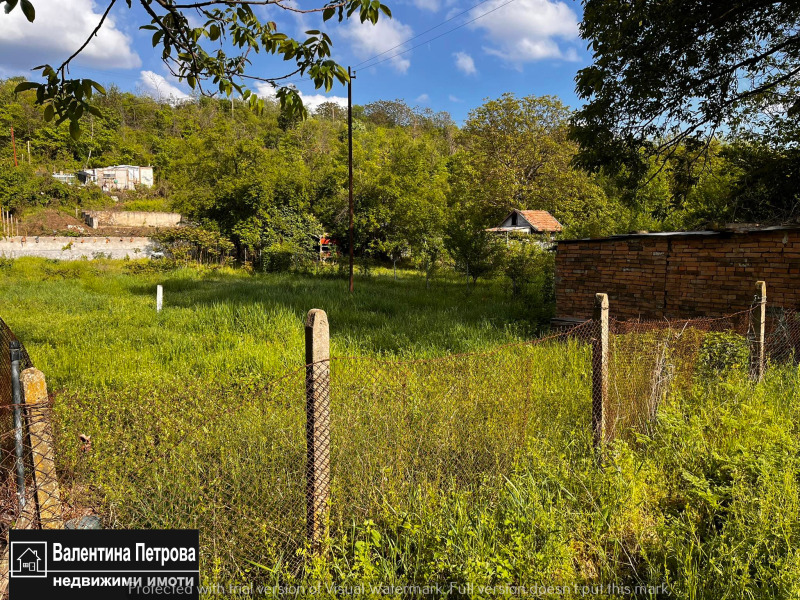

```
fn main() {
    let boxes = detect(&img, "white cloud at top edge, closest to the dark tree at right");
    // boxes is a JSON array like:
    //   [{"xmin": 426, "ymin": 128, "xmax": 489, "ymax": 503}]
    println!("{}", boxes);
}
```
[{"xmin": 470, "ymin": 0, "xmax": 578, "ymax": 66}]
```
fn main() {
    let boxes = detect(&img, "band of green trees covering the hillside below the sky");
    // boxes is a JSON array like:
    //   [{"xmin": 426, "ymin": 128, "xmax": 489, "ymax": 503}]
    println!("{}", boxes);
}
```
[{"xmin": 0, "ymin": 78, "xmax": 799, "ymax": 264}]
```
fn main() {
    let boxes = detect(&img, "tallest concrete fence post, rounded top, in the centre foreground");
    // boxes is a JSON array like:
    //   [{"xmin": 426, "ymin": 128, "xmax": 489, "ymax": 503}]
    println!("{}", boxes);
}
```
[{"xmin": 306, "ymin": 308, "xmax": 331, "ymax": 551}]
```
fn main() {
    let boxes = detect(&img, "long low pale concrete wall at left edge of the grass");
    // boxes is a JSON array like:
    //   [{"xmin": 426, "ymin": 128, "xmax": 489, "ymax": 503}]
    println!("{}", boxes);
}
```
[{"xmin": 0, "ymin": 236, "xmax": 160, "ymax": 260}]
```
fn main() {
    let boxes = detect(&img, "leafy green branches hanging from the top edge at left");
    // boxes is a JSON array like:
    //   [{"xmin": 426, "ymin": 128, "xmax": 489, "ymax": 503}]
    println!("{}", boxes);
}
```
[{"xmin": 3, "ymin": 0, "xmax": 391, "ymax": 138}]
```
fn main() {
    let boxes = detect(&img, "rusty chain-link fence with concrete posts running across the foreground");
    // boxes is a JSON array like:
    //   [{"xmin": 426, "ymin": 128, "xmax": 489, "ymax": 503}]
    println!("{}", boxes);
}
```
[{"xmin": 3, "ymin": 285, "xmax": 800, "ymax": 583}]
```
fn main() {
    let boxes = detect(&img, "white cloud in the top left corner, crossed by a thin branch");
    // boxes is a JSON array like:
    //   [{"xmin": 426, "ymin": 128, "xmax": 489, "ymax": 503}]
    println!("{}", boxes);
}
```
[{"xmin": 0, "ymin": 0, "xmax": 142, "ymax": 72}]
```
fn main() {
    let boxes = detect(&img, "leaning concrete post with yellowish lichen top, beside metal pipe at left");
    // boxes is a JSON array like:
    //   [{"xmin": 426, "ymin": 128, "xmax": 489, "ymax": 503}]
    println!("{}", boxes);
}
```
[{"xmin": 20, "ymin": 368, "xmax": 64, "ymax": 529}]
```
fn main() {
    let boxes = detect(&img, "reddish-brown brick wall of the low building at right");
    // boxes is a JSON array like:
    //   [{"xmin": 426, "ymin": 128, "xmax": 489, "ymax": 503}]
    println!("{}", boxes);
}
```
[{"xmin": 556, "ymin": 228, "xmax": 800, "ymax": 319}]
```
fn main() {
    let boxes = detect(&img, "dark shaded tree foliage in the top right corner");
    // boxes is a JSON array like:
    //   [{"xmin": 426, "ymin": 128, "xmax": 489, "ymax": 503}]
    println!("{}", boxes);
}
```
[{"xmin": 572, "ymin": 0, "xmax": 800, "ymax": 183}]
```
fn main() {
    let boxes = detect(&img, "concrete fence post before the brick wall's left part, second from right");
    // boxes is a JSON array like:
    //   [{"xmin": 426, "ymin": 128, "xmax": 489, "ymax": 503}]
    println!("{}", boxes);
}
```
[{"xmin": 592, "ymin": 294, "xmax": 614, "ymax": 447}]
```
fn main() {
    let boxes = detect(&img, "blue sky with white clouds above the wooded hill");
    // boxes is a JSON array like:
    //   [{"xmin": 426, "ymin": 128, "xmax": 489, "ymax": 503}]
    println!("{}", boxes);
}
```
[{"xmin": 0, "ymin": 0, "xmax": 590, "ymax": 123}]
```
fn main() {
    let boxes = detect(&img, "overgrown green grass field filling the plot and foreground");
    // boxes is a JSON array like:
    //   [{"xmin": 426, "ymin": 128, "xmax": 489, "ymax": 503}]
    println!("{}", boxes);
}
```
[{"xmin": 0, "ymin": 260, "xmax": 800, "ymax": 598}]
